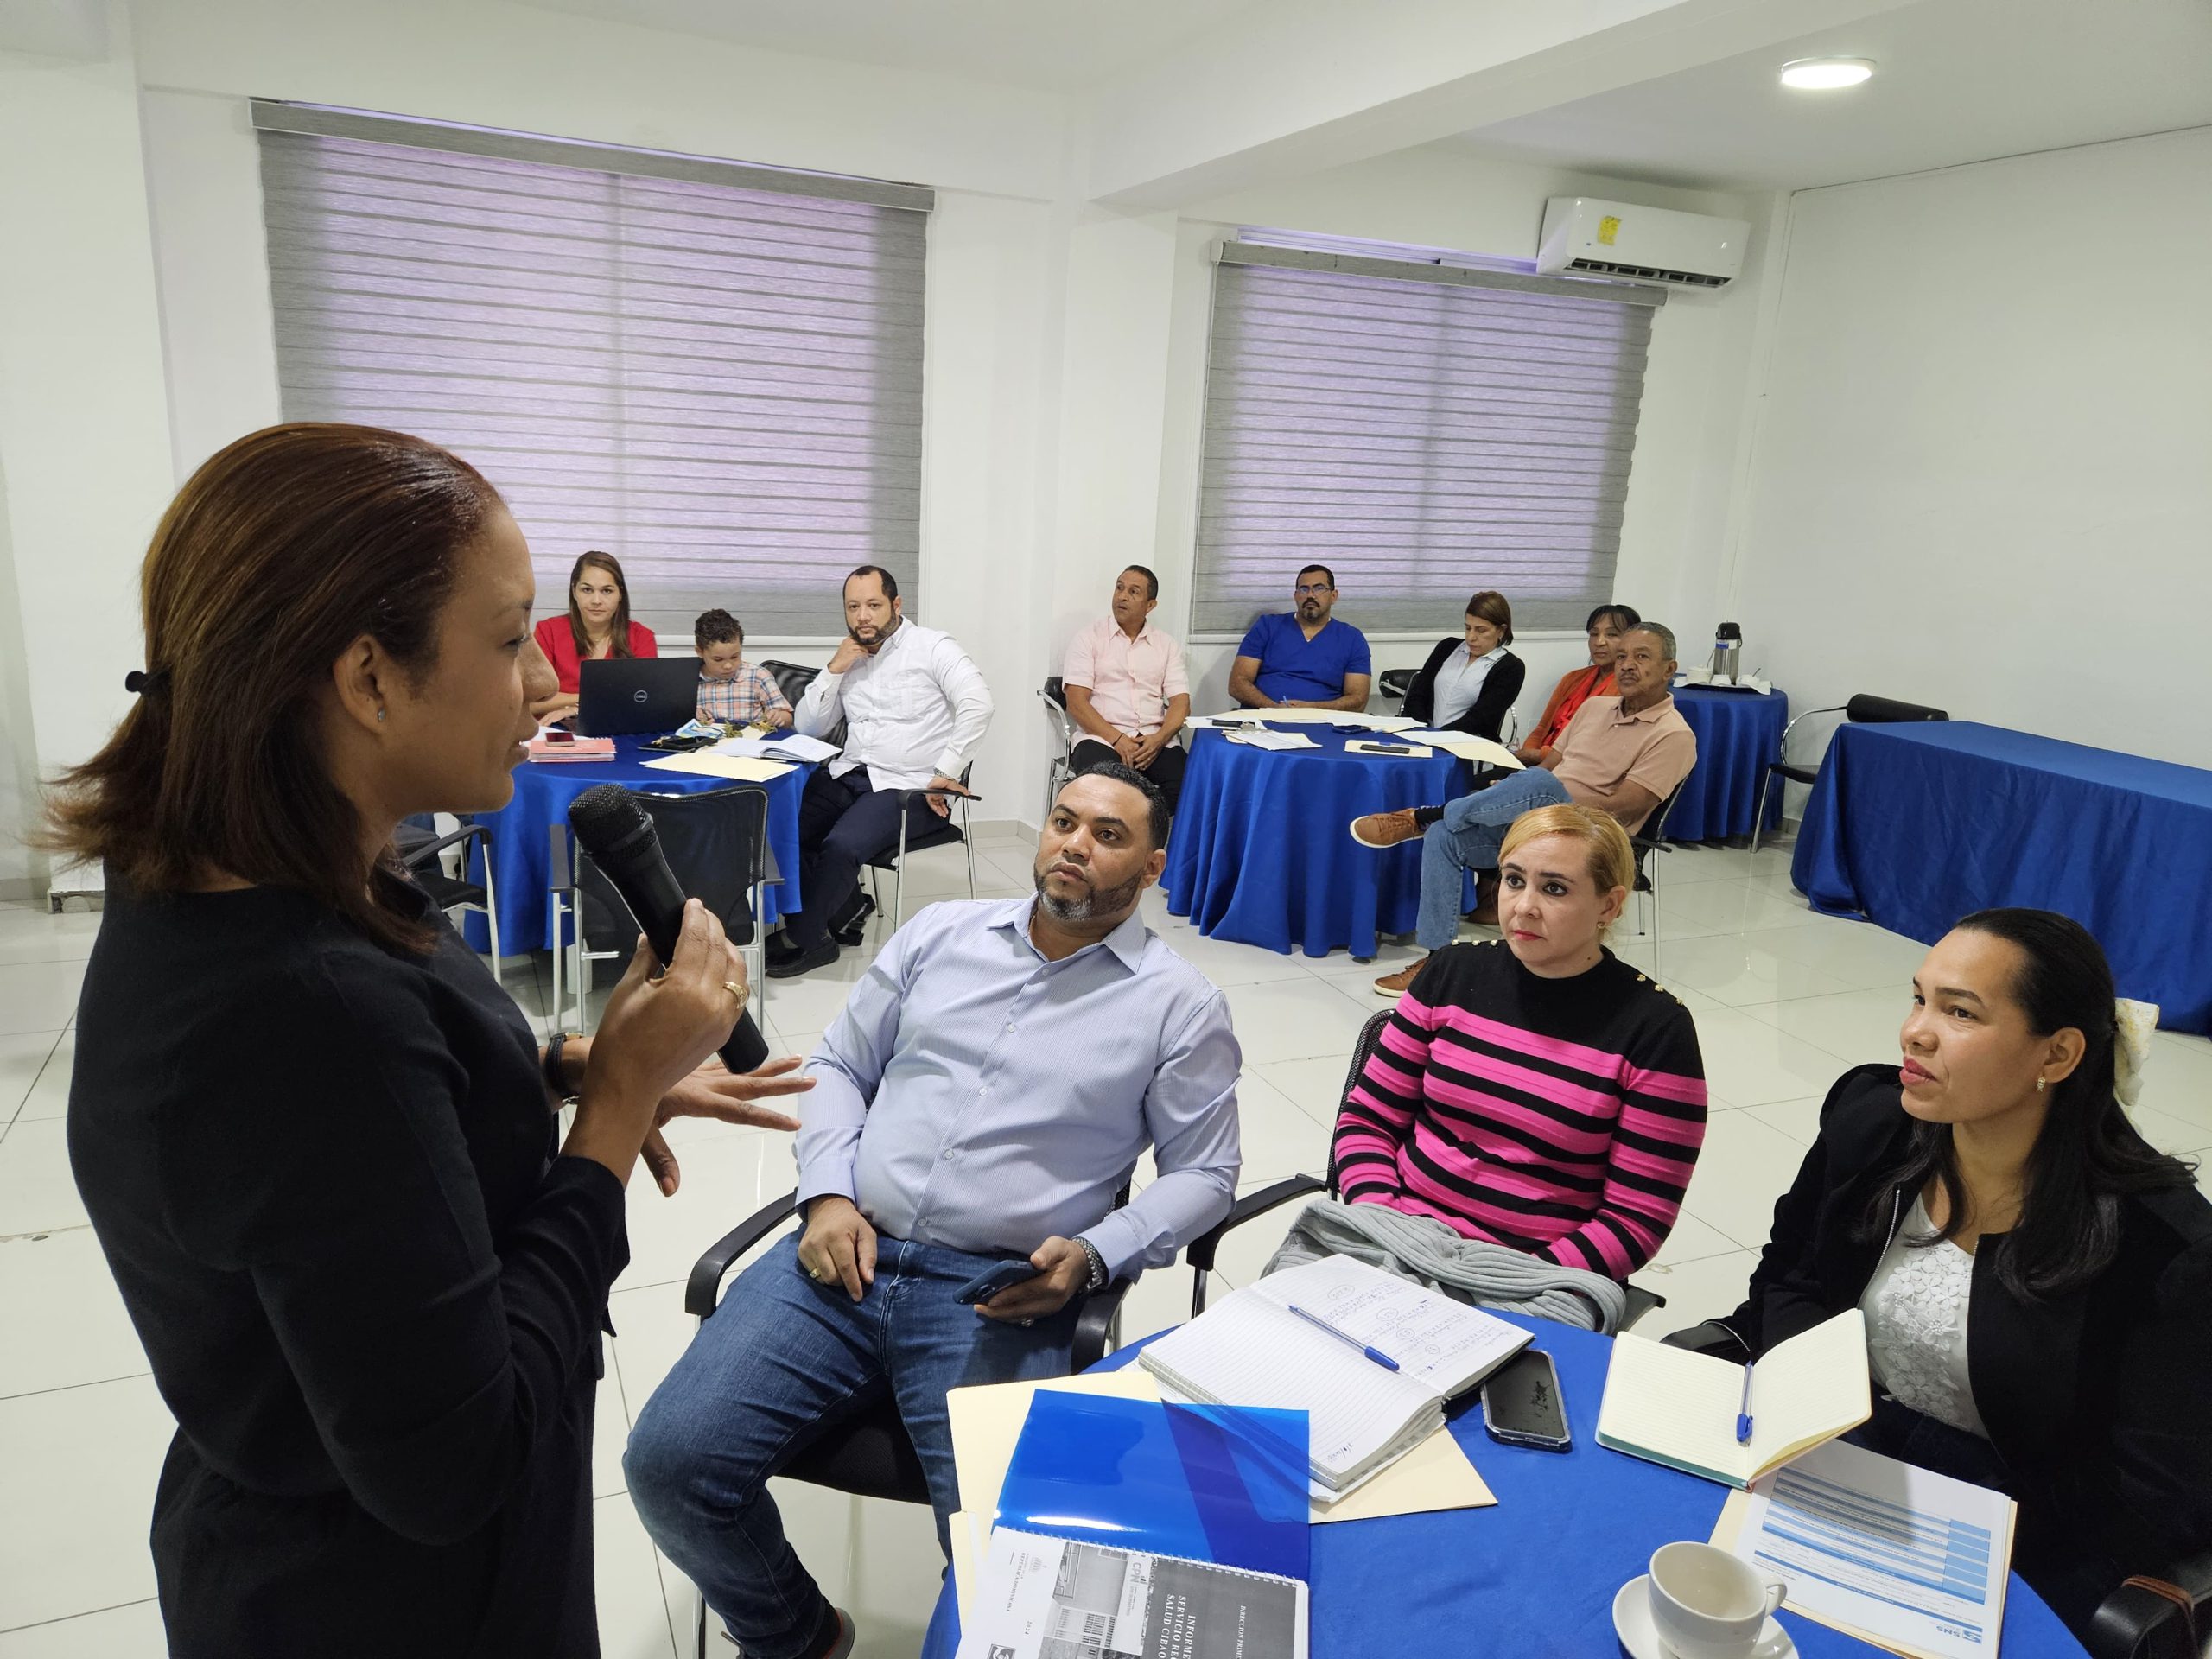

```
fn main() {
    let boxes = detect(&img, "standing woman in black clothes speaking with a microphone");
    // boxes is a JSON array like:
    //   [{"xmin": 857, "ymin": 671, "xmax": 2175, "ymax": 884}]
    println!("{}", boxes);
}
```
[{"xmin": 47, "ymin": 425, "xmax": 803, "ymax": 1659}]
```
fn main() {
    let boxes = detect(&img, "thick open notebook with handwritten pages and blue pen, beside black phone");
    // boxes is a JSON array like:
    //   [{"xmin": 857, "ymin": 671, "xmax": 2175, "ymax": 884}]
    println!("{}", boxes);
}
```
[{"xmin": 1137, "ymin": 1256, "xmax": 1529, "ymax": 1496}]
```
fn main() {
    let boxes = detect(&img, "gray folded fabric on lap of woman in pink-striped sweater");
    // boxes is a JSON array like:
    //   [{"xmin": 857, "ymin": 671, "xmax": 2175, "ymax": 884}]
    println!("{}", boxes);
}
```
[{"xmin": 1268, "ymin": 1199, "xmax": 1628, "ymax": 1336}]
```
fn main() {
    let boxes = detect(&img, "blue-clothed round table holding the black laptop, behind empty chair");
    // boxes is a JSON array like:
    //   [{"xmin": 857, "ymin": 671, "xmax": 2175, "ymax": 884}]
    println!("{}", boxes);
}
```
[{"xmin": 467, "ymin": 736, "xmax": 812, "ymax": 956}]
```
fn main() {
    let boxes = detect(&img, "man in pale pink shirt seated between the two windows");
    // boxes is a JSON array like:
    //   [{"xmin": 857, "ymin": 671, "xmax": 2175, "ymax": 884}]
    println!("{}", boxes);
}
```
[{"xmin": 1059, "ymin": 564, "xmax": 1190, "ymax": 812}]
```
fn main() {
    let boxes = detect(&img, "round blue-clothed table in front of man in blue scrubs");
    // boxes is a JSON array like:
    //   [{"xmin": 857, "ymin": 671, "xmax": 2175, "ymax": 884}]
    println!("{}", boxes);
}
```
[{"xmin": 1161, "ymin": 723, "xmax": 1471, "ymax": 956}]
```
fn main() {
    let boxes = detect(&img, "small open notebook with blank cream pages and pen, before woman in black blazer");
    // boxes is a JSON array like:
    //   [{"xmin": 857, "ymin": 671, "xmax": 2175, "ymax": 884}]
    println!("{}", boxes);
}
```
[{"xmin": 1597, "ymin": 1307, "xmax": 1873, "ymax": 1486}]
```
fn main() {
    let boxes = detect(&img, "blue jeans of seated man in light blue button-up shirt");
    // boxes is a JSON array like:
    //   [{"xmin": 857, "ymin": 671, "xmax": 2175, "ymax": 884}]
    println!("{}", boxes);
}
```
[{"xmin": 621, "ymin": 1236, "xmax": 1082, "ymax": 1659}]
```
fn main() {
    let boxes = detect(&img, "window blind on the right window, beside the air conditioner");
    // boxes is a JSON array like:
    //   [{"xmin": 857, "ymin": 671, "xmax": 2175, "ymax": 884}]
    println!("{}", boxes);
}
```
[{"xmin": 1190, "ymin": 244, "xmax": 1666, "ymax": 632}]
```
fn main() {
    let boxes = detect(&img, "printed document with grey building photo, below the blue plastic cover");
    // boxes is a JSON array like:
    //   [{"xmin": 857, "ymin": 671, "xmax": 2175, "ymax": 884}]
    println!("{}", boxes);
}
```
[{"xmin": 957, "ymin": 1526, "xmax": 1307, "ymax": 1659}]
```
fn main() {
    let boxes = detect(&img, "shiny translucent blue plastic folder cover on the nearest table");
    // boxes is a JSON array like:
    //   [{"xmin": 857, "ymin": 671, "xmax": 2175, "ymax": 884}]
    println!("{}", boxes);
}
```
[{"xmin": 995, "ymin": 1389, "xmax": 1312, "ymax": 1580}]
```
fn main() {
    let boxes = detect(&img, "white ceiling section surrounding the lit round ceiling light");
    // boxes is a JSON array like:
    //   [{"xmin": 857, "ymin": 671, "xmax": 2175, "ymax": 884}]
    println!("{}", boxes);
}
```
[{"xmin": 1449, "ymin": 0, "xmax": 2212, "ymax": 194}]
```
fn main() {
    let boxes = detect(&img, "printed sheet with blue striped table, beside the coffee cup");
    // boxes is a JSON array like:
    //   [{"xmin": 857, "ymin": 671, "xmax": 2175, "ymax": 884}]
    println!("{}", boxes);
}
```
[{"xmin": 1712, "ymin": 1440, "xmax": 2018, "ymax": 1659}]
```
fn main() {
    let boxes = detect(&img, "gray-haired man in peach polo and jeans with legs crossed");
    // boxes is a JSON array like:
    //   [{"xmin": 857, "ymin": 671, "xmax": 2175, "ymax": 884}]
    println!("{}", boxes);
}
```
[{"xmin": 1351, "ymin": 621, "xmax": 1697, "ymax": 998}]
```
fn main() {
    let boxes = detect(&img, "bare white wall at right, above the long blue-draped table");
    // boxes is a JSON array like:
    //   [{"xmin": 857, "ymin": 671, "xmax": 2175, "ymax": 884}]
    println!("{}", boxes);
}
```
[{"xmin": 1738, "ymin": 128, "xmax": 2212, "ymax": 766}]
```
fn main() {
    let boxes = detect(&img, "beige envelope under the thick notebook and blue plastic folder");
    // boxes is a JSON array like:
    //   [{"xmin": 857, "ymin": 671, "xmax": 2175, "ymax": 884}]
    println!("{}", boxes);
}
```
[{"xmin": 944, "ymin": 1365, "xmax": 1497, "ymax": 1615}]
